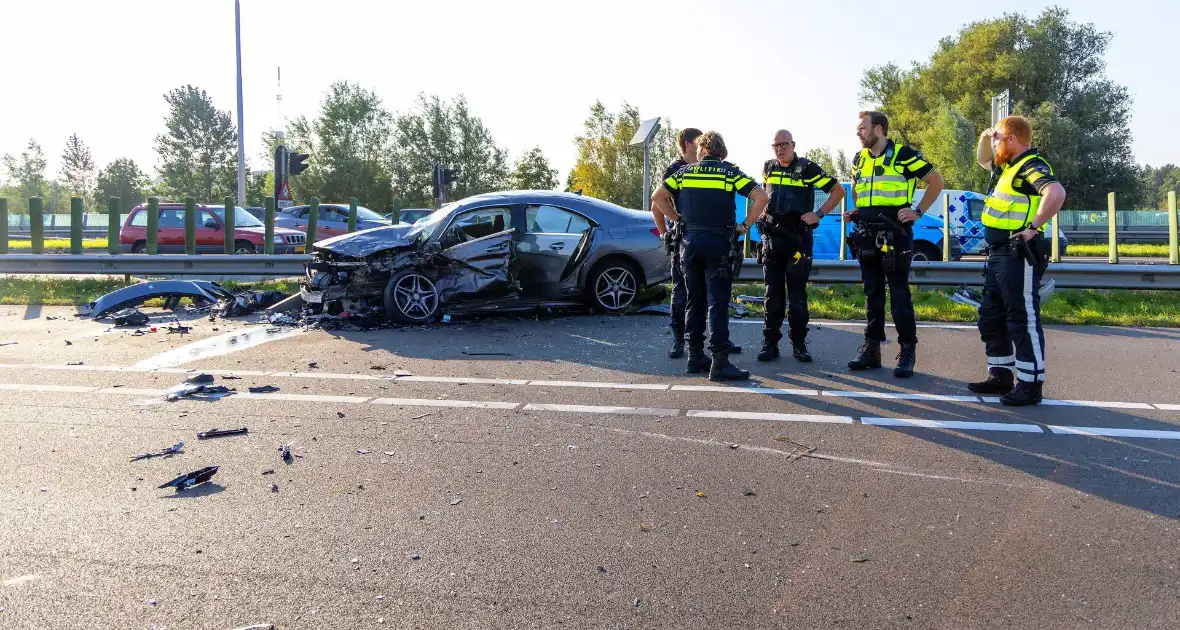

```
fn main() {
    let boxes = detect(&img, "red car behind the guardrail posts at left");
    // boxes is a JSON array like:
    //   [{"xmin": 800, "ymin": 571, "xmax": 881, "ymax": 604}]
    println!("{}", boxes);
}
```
[{"xmin": 119, "ymin": 203, "xmax": 304, "ymax": 254}]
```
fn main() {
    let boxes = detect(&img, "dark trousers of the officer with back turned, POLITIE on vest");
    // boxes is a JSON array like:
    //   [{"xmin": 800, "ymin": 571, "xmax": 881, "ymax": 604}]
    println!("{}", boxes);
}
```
[{"xmin": 680, "ymin": 230, "xmax": 733, "ymax": 354}]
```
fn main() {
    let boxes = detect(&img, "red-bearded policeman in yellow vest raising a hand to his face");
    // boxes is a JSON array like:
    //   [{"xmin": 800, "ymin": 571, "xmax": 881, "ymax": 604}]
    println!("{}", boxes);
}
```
[{"xmin": 968, "ymin": 116, "xmax": 1066, "ymax": 406}]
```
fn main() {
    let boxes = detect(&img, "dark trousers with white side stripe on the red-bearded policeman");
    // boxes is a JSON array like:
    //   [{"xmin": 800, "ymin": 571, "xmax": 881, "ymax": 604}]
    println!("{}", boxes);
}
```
[{"xmin": 978, "ymin": 237, "xmax": 1045, "ymax": 382}]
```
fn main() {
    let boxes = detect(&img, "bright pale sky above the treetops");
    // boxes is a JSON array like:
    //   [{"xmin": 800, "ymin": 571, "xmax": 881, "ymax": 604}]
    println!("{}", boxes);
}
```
[{"xmin": 0, "ymin": 0, "xmax": 1180, "ymax": 188}]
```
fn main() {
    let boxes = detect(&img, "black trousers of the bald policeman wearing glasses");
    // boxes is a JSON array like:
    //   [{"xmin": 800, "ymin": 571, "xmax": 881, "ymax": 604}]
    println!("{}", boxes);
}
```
[{"xmin": 762, "ymin": 228, "xmax": 814, "ymax": 343}]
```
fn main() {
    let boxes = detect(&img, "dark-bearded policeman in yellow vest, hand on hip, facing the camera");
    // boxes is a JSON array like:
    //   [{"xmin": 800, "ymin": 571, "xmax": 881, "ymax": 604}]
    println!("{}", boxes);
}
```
[{"xmin": 844, "ymin": 112, "xmax": 943, "ymax": 379}]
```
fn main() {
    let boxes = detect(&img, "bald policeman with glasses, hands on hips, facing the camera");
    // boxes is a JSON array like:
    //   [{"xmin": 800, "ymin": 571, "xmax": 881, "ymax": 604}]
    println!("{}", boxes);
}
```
[{"xmin": 758, "ymin": 129, "xmax": 844, "ymax": 363}]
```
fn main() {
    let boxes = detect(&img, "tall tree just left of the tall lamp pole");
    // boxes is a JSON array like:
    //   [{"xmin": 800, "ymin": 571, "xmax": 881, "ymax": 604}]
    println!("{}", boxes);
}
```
[{"xmin": 156, "ymin": 85, "xmax": 237, "ymax": 202}]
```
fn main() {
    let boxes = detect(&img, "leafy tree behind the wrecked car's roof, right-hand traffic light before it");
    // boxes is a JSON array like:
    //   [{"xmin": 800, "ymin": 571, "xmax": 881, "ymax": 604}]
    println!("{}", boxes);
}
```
[{"xmin": 389, "ymin": 94, "xmax": 509, "ymax": 208}]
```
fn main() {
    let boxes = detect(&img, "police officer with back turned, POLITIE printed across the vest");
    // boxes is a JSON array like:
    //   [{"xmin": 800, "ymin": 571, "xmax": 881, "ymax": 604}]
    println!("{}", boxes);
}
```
[{"xmin": 651, "ymin": 131, "xmax": 768, "ymax": 381}]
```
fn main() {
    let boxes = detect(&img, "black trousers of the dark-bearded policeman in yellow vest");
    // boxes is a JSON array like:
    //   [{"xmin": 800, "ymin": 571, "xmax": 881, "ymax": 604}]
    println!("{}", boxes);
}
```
[{"xmin": 860, "ymin": 235, "xmax": 918, "ymax": 343}]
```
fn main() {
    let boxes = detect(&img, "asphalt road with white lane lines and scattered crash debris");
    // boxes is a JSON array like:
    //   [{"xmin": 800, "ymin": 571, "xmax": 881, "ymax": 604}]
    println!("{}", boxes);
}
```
[{"xmin": 0, "ymin": 307, "xmax": 1180, "ymax": 630}]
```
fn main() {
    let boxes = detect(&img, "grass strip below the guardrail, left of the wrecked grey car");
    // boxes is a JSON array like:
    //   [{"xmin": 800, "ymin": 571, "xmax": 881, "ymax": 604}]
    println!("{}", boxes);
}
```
[{"xmin": 0, "ymin": 276, "xmax": 299, "ymax": 307}]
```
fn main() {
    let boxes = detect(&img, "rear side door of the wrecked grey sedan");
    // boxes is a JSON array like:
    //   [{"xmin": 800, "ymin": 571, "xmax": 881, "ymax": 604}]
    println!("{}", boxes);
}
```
[{"xmin": 517, "ymin": 204, "xmax": 590, "ymax": 300}]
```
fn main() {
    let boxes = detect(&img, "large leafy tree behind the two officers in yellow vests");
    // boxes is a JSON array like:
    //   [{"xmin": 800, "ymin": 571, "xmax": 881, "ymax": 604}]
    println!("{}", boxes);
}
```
[{"xmin": 860, "ymin": 8, "xmax": 1142, "ymax": 208}]
